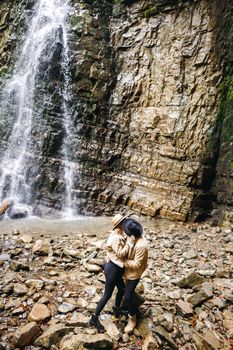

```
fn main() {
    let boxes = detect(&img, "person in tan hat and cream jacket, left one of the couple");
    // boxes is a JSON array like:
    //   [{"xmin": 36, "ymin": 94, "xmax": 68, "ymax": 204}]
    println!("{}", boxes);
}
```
[{"xmin": 89, "ymin": 214, "xmax": 135, "ymax": 332}]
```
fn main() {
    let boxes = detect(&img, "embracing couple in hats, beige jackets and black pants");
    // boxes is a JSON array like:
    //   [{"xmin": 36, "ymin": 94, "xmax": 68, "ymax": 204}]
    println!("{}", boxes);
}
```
[{"xmin": 89, "ymin": 214, "xmax": 148, "ymax": 333}]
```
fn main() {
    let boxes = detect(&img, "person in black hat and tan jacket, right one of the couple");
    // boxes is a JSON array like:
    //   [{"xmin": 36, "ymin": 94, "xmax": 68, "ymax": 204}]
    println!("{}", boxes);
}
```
[{"xmin": 121, "ymin": 218, "xmax": 148, "ymax": 333}]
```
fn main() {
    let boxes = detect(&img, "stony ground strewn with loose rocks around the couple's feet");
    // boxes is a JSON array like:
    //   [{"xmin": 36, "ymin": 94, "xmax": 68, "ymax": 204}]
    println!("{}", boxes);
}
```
[{"xmin": 0, "ymin": 217, "xmax": 233, "ymax": 350}]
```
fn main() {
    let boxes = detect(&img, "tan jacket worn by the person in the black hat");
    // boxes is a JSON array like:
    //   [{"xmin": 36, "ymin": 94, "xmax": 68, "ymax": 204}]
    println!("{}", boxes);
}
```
[{"xmin": 124, "ymin": 237, "xmax": 148, "ymax": 280}]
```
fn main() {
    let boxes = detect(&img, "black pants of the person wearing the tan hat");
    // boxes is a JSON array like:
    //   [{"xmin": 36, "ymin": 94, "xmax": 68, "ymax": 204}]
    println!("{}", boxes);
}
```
[{"xmin": 95, "ymin": 261, "xmax": 125, "ymax": 316}]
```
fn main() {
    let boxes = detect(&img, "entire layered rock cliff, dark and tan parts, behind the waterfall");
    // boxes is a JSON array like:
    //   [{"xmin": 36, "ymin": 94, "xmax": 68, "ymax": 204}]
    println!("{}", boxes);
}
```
[{"xmin": 1, "ymin": 0, "xmax": 232, "ymax": 221}]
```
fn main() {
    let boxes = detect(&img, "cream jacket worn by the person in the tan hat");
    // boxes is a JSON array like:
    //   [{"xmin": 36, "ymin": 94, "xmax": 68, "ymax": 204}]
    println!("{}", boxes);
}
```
[{"xmin": 106, "ymin": 228, "xmax": 132, "ymax": 267}]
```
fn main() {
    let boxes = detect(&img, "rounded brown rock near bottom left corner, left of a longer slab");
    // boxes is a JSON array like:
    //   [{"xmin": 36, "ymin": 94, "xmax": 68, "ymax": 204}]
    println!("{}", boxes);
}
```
[{"xmin": 14, "ymin": 322, "xmax": 41, "ymax": 348}]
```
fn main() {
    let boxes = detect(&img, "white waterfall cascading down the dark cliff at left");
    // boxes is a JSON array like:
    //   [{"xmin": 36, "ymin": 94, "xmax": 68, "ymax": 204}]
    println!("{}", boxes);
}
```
[{"xmin": 0, "ymin": 0, "xmax": 74, "ymax": 215}]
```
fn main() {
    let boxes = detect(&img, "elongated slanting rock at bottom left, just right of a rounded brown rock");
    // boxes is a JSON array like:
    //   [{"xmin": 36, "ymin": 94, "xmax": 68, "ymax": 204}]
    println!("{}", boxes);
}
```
[{"xmin": 34, "ymin": 324, "xmax": 73, "ymax": 350}]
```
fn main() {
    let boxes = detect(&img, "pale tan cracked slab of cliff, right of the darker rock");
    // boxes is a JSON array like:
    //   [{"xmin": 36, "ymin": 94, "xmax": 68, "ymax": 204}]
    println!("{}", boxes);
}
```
[{"xmin": 105, "ymin": 1, "xmax": 221, "ymax": 220}]
